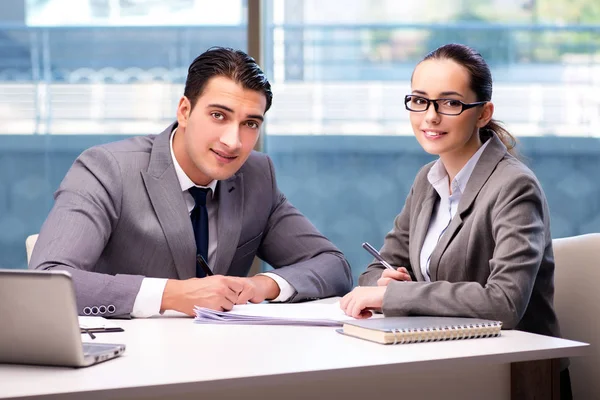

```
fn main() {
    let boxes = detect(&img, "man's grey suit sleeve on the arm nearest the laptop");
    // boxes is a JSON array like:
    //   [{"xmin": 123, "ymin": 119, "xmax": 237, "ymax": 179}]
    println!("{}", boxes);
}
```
[{"xmin": 30, "ymin": 147, "xmax": 143, "ymax": 317}]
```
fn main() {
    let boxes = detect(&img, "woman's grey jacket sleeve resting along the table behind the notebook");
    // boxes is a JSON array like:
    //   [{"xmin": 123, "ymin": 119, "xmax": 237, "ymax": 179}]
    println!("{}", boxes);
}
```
[{"xmin": 383, "ymin": 175, "xmax": 547, "ymax": 329}]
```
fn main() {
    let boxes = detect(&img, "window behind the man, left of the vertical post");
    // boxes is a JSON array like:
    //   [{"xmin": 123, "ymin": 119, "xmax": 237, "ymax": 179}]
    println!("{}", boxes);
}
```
[{"xmin": 0, "ymin": 0, "xmax": 247, "ymax": 268}]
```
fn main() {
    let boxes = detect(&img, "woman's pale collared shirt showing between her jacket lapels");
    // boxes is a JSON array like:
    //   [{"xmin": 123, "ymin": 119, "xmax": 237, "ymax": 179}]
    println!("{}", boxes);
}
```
[{"xmin": 420, "ymin": 140, "xmax": 489, "ymax": 282}]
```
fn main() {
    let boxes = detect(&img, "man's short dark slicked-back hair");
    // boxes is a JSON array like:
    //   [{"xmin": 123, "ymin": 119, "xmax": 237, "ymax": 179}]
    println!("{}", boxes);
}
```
[{"xmin": 183, "ymin": 47, "xmax": 273, "ymax": 112}]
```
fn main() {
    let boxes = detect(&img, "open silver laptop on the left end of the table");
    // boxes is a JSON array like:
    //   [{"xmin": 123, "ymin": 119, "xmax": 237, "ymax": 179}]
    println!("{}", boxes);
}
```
[{"xmin": 0, "ymin": 269, "xmax": 125, "ymax": 367}]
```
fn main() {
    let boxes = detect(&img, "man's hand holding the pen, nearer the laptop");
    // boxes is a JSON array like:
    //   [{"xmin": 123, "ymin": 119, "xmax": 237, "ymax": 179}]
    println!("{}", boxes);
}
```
[{"xmin": 160, "ymin": 275, "xmax": 244, "ymax": 316}]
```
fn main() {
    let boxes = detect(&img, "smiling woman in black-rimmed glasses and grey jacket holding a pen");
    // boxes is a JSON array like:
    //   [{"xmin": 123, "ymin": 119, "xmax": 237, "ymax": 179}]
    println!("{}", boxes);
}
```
[{"xmin": 340, "ymin": 44, "xmax": 568, "ymax": 396}]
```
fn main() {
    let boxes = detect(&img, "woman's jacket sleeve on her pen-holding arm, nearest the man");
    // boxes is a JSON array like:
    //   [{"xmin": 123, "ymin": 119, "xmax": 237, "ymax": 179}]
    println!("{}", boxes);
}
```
[{"xmin": 358, "ymin": 187, "xmax": 414, "ymax": 286}]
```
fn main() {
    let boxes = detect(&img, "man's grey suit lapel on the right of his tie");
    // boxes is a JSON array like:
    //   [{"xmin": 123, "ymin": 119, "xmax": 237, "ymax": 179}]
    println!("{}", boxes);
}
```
[{"xmin": 213, "ymin": 173, "xmax": 244, "ymax": 275}]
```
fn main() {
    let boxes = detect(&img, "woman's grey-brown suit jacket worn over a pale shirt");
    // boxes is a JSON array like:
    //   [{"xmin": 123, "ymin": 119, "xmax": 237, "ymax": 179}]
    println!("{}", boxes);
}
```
[{"xmin": 359, "ymin": 135, "xmax": 560, "ymax": 336}]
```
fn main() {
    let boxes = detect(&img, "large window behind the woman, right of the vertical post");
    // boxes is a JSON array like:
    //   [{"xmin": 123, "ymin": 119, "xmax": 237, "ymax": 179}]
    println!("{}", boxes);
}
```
[{"xmin": 265, "ymin": 0, "xmax": 600, "ymax": 281}]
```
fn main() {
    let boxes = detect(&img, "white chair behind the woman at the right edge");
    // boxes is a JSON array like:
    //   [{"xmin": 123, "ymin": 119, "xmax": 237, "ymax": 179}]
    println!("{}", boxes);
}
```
[{"xmin": 552, "ymin": 233, "xmax": 600, "ymax": 399}]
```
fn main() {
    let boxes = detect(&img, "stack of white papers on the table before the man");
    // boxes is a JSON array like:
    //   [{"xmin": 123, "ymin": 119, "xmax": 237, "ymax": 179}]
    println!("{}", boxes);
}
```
[{"xmin": 195, "ymin": 302, "xmax": 354, "ymax": 326}]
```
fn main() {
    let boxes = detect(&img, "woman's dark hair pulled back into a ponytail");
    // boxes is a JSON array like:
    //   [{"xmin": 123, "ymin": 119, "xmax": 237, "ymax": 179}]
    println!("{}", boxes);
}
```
[{"xmin": 423, "ymin": 43, "xmax": 517, "ymax": 155}]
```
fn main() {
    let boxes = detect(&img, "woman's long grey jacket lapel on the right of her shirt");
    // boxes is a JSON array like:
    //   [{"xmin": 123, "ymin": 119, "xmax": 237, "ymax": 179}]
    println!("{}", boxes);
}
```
[{"xmin": 429, "ymin": 134, "xmax": 506, "ymax": 281}]
